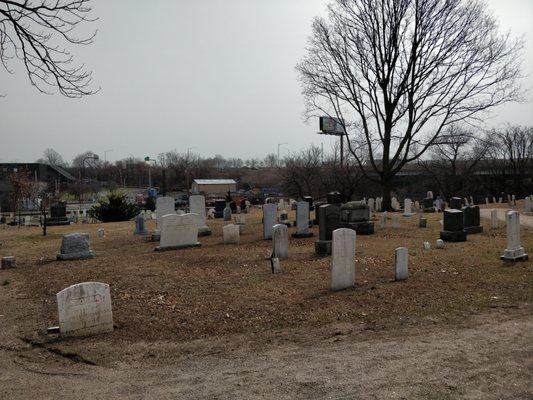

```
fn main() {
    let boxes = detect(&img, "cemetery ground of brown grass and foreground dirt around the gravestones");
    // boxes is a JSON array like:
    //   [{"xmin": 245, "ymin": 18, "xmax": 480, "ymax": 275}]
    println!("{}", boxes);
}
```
[{"xmin": 0, "ymin": 203, "xmax": 533, "ymax": 399}]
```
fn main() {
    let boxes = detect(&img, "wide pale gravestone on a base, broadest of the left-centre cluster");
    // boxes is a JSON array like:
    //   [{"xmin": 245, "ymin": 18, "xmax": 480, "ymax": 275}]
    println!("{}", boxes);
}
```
[{"xmin": 155, "ymin": 214, "xmax": 201, "ymax": 251}]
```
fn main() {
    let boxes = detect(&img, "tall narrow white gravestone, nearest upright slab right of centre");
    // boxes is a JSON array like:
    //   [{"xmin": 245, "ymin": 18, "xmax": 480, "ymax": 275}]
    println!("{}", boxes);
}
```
[{"xmin": 331, "ymin": 228, "xmax": 357, "ymax": 290}]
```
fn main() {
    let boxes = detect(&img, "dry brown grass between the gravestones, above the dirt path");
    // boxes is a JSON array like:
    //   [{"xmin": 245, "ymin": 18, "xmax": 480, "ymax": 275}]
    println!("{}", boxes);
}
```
[{"xmin": 0, "ymin": 210, "xmax": 533, "ymax": 342}]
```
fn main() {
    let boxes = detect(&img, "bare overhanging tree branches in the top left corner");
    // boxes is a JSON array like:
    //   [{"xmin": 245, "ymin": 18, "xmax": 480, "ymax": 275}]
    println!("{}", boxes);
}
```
[{"xmin": 0, "ymin": 0, "xmax": 96, "ymax": 97}]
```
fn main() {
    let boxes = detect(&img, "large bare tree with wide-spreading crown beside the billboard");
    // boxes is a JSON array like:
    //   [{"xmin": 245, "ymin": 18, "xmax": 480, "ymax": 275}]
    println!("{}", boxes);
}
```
[{"xmin": 297, "ymin": 0, "xmax": 523, "ymax": 209}]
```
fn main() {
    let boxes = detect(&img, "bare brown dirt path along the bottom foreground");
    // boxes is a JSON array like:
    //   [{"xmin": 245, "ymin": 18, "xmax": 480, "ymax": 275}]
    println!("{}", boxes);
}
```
[{"xmin": 0, "ymin": 309, "xmax": 533, "ymax": 400}]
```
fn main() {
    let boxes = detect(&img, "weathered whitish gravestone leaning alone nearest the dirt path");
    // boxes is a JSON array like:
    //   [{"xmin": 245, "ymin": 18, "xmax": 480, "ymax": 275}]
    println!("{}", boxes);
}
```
[{"xmin": 56, "ymin": 282, "xmax": 113, "ymax": 336}]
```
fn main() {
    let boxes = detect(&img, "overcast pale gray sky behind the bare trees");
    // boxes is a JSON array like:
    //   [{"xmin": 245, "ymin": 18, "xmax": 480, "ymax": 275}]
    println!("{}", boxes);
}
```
[{"xmin": 0, "ymin": 0, "xmax": 533, "ymax": 162}]
